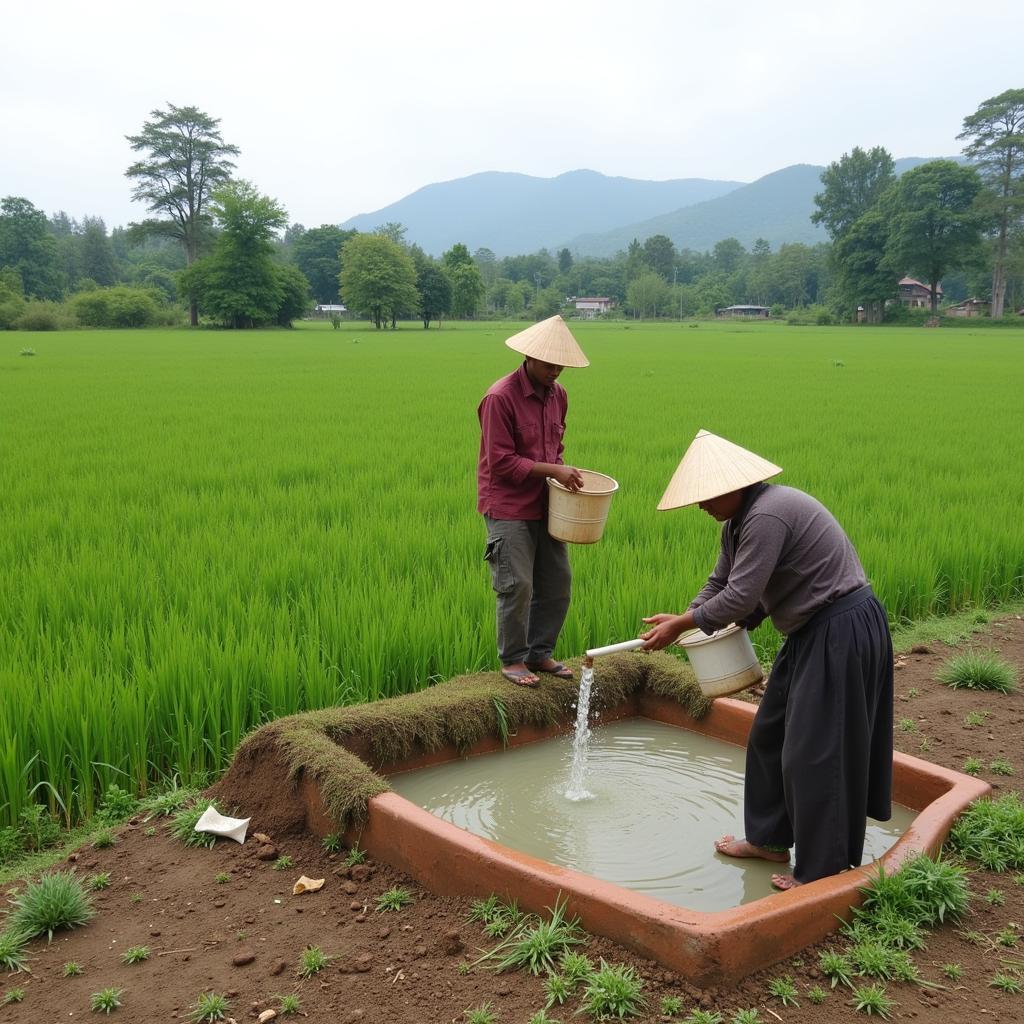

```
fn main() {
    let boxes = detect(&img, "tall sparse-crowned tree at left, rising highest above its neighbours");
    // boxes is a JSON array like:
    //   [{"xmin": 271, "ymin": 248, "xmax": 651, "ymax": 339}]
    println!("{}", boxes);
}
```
[{"xmin": 125, "ymin": 103, "xmax": 239, "ymax": 327}]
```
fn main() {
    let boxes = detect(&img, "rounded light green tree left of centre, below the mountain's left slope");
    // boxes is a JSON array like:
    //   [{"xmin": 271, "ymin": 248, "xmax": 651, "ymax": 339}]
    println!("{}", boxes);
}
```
[{"xmin": 341, "ymin": 234, "xmax": 420, "ymax": 329}]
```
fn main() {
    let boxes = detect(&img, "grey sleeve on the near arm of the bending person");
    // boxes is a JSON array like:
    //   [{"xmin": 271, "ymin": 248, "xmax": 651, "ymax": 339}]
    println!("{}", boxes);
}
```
[{"xmin": 693, "ymin": 515, "xmax": 788, "ymax": 633}]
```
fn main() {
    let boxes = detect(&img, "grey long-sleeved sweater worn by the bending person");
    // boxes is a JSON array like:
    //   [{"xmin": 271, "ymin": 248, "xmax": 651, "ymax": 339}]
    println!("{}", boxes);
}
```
[{"xmin": 690, "ymin": 483, "xmax": 867, "ymax": 635}]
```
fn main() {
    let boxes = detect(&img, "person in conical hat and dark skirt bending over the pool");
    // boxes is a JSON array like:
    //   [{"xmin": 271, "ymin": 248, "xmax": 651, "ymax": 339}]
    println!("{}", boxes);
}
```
[{"xmin": 643, "ymin": 430, "xmax": 893, "ymax": 889}]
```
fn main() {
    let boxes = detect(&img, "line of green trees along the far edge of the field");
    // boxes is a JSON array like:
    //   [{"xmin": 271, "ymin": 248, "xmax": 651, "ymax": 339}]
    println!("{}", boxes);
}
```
[{"xmin": 0, "ymin": 89, "xmax": 1024, "ymax": 328}]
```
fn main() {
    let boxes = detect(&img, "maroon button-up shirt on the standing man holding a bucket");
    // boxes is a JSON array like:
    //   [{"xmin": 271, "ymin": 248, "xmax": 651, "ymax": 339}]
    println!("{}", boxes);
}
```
[{"xmin": 476, "ymin": 364, "xmax": 568, "ymax": 519}]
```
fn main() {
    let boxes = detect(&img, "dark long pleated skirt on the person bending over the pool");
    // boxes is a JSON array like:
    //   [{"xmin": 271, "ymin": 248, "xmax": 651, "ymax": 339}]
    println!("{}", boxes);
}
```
[{"xmin": 743, "ymin": 587, "xmax": 893, "ymax": 882}]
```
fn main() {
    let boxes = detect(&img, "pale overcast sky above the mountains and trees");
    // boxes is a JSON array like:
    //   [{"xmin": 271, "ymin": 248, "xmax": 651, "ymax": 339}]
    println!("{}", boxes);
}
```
[{"xmin": 0, "ymin": 0, "xmax": 1024, "ymax": 227}]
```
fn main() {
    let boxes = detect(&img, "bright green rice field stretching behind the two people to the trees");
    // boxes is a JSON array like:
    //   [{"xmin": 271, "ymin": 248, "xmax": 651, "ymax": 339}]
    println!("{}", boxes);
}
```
[{"xmin": 0, "ymin": 324, "xmax": 1024, "ymax": 825}]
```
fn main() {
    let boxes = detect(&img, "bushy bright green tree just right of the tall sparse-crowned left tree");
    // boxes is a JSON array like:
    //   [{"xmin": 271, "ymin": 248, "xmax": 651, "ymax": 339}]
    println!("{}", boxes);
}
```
[{"xmin": 181, "ymin": 181, "xmax": 308, "ymax": 328}]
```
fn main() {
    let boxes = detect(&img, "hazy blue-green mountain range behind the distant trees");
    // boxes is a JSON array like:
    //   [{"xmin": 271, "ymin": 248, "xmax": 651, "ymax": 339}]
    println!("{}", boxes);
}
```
[{"xmin": 341, "ymin": 157, "xmax": 931, "ymax": 256}]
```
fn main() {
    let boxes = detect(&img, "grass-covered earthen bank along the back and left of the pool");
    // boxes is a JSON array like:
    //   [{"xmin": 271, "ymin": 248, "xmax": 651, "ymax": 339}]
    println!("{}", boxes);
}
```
[{"xmin": 213, "ymin": 653, "xmax": 711, "ymax": 833}]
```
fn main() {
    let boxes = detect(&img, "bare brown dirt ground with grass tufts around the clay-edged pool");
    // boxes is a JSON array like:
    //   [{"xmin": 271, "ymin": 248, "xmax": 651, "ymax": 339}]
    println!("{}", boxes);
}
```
[{"xmin": 0, "ymin": 615, "xmax": 1024, "ymax": 1024}]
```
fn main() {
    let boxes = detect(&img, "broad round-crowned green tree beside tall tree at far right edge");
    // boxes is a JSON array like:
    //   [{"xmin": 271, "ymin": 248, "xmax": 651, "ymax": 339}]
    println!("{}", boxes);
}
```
[{"xmin": 886, "ymin": 160, "xmax": 983, "ymax": 315}]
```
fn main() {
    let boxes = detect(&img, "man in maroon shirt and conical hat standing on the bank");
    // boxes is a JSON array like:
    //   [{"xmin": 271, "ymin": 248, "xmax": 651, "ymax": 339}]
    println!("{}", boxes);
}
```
[{"xmin": 476, "ymin": 316, "xmax": 590, "ymax": 686}]
